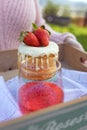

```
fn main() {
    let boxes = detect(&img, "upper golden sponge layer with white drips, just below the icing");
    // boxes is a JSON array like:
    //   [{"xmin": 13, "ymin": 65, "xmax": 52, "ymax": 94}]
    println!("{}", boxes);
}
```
[{"xmin": 18, "ymin": 54, "xmax": 58, "ymax": 71}]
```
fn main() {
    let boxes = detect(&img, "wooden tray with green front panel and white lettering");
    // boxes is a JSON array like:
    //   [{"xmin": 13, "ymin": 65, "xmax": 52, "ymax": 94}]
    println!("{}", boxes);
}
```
[{"xmin": 0, "ymin": 44, "xmax": 87, "ymax": 130}]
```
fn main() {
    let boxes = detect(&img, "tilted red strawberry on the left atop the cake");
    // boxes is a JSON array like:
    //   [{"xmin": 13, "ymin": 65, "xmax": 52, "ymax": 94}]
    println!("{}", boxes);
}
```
[{"xmin": 20, "ymin": 32, "xmax": 40, "ymax": 47}]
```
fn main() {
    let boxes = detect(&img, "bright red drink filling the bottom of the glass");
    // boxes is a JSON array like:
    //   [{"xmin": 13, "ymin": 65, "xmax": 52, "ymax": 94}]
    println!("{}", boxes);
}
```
[{"xmin": 19, "ymin": 82, "xmax": 63, "ymax": 113}]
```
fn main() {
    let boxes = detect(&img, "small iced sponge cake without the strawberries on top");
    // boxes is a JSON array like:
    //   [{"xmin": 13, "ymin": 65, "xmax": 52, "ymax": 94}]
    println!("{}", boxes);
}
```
[{"xmin": 18, "ymin": 42, "xmax": 58, "ymax": 80}]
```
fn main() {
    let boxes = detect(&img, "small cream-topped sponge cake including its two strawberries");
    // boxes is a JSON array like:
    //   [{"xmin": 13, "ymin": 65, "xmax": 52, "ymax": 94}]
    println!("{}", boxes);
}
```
[{"xmin": 18, "ymin": 23, "xmax": 59, "ymax": 80}]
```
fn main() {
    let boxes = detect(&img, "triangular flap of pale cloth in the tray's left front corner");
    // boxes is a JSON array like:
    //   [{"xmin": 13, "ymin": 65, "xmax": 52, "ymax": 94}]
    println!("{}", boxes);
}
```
[{"xmin": 0, "ymin": 76, "xmax": 21, "ymax": 121}]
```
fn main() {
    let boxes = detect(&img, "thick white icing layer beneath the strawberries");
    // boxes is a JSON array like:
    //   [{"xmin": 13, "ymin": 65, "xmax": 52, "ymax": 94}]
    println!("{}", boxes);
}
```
[{"xmin": 18, "ymin": 41, "xmax": 59, "ymax": 57}]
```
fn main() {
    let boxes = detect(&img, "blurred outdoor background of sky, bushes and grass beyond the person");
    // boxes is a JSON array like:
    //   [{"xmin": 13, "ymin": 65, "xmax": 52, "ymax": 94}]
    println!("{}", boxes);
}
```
[{"xmin": 39, "ymin": 0, "xmax": 87, "ymax": 51}]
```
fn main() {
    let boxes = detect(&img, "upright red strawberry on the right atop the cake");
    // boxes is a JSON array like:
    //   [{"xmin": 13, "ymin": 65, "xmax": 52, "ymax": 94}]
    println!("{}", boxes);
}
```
[{"xmin": 34, "ymin": 26, "xmax": 50, "ymax": 46}]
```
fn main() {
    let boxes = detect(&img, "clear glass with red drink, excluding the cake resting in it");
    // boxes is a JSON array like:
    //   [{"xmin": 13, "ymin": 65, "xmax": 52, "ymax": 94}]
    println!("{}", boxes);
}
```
[{"xmin": 18, "ymin": 61, "xmax": 64, "ymax": 114}]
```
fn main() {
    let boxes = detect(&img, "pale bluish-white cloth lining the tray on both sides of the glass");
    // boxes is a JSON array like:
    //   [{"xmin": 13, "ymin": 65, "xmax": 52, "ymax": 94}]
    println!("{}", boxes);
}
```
[{"xmin": 0, "ymin": 68, "xmax": 87, "ymax": 121}]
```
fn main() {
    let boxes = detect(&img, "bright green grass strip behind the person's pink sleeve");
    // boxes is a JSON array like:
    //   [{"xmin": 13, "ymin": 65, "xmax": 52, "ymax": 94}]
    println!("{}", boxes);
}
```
[{"xmin": 49, "ymin": 24, "xmax": 87, "ymax": 51}]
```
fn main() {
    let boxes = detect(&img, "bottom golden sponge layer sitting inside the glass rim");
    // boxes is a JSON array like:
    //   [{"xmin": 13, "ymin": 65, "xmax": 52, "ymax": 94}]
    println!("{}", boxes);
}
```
[{"xmin": 19, "ymin": 62, "xmax": 61, "ymax": 80}]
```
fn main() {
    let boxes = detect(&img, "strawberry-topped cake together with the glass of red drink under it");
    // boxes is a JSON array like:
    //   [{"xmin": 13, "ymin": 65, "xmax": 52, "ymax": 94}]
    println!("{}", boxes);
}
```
[{"xmin": 18, "ymin": 24, "xmax": 64, "ymax": 114}]
